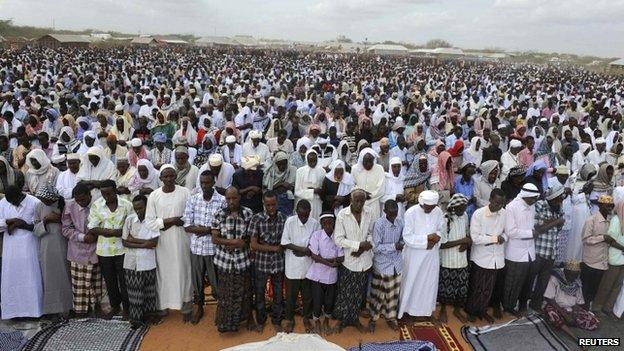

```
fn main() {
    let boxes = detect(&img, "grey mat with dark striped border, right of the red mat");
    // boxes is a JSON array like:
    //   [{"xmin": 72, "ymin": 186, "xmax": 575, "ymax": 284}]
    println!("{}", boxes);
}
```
[{"xmin": 462, "ymin": 315, "xmax": 570, "ymax": 351}]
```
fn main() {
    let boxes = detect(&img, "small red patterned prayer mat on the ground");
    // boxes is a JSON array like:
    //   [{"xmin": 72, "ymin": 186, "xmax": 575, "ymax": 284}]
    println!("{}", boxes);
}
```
[{"xmin": 400, "ymin": 322, "xmax": 463, "ymax": 351}]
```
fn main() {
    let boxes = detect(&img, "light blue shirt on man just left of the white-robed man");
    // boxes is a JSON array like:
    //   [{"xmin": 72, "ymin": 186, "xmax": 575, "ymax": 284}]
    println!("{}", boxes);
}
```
[{"xmin": 373, "ymin": 215, "xmax": 403, "ymax": 275}]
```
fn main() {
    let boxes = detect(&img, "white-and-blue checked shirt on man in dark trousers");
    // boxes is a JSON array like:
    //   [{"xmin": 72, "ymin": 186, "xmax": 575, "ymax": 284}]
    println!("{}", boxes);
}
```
[{"xmin": 182, "ymin": 191, "xmax": 227, "ymax": 256}]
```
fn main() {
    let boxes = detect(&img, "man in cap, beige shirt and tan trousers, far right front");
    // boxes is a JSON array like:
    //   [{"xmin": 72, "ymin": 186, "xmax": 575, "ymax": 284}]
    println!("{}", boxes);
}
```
[{"xmin": 581, "ymin": 195, "xmax": 619, "ymax": 310}]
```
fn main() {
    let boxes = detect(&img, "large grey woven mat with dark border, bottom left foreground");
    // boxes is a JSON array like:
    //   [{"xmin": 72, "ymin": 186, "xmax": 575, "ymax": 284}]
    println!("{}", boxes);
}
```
[{"xmin": 23, "ymin": 319, "xmax": 147, "ymax": 351}]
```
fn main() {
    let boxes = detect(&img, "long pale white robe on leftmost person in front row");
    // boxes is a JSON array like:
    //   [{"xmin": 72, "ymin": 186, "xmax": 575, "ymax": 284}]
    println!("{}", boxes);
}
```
[{"xmin": 0, "ymin": 195, "xmax": 43, "ymax": 319}]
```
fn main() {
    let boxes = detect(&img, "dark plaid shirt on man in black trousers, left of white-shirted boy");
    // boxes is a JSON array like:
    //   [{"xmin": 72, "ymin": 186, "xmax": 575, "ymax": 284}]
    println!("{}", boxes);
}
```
[{"xmin": 249, "ymin": 212, "xmax": 286, "ymax": 273}]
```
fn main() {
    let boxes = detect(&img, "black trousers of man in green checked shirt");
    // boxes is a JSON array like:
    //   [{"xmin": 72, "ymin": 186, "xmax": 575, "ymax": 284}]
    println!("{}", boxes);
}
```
[{"xmin": 98, "ymin": 255, "xmax": 130, "ymax": 311}]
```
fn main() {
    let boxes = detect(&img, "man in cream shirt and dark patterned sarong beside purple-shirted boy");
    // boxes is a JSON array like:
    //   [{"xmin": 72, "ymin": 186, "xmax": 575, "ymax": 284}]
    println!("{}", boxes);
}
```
[{"xmin": 334, "ymin": 190, "xmax": 372, "ymax": 333}]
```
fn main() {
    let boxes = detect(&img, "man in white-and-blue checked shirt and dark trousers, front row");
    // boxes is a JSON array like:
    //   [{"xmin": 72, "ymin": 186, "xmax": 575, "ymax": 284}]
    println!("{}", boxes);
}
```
[{"xmin": 182, "ymin": 171, "xmax": 226, "ymax": 324}]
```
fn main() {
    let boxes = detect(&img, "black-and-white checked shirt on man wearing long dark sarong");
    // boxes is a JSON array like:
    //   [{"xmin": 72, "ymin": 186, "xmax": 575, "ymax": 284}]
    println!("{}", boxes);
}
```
[{"xmin": 212, "ymin": 207, "xmax": 253, "ymax": 272}]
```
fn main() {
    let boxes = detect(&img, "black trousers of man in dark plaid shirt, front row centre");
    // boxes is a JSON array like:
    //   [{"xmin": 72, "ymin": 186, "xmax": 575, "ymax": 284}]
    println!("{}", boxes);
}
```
[{"xmin": 254, "ymin": 269, "xmax": 284, "ymax": 324}]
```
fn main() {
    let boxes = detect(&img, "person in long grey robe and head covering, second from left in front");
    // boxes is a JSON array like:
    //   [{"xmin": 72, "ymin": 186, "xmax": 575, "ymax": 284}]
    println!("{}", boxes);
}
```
[{"xmin": 33, "ymin": 184, "xmax": 73, "ymax": 317}]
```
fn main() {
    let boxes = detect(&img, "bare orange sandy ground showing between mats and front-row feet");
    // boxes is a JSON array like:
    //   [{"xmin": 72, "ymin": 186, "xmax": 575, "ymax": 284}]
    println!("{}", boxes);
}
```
[{"xmin": 141, "ymin": 305, "xmax": 511, "ymax": 351}]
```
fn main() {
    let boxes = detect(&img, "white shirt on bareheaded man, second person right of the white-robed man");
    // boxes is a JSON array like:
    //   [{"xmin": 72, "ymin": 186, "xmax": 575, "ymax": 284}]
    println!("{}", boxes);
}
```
[{"xmin": 470, "ymin": 206, "xmax": 507, "ymax": 269}]
